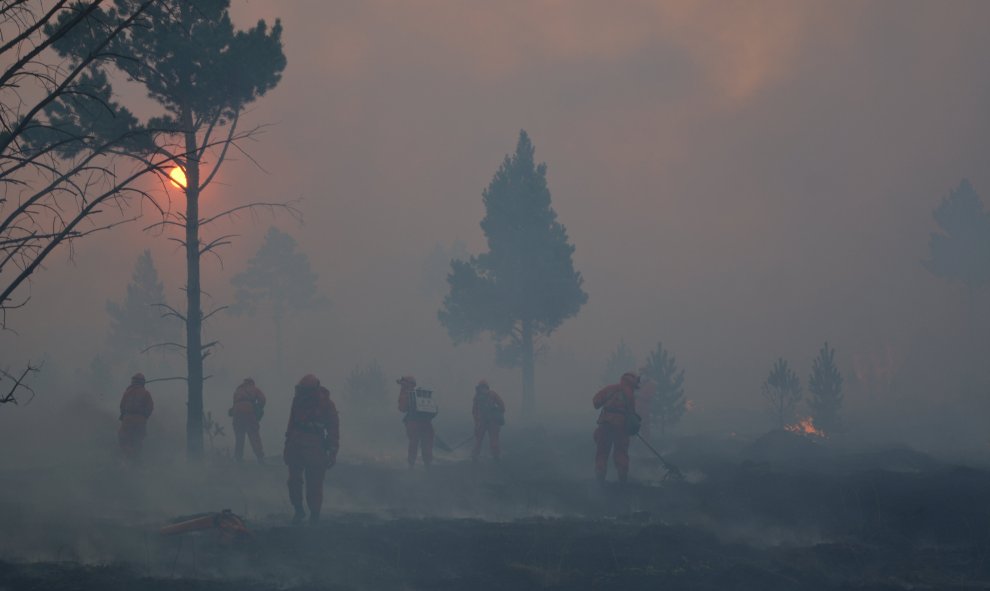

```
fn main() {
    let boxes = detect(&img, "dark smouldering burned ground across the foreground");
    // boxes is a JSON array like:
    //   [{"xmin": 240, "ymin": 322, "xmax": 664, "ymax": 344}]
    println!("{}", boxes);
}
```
[{"xmin": 0, "ymin": 433, "xmax": 990, "ymax": 590}]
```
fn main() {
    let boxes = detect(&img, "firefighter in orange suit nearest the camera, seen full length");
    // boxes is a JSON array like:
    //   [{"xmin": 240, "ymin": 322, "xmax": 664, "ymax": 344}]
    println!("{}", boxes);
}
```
[{"xmin": 282, "ymin": 374, "xmax": 340, "ymax": 522}]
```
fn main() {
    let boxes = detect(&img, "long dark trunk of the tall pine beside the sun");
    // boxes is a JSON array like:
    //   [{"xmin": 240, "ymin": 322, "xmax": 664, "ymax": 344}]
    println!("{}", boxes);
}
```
[{"xmin": 183, "ymin": 123, "xmax": 203, "ymax": 461}]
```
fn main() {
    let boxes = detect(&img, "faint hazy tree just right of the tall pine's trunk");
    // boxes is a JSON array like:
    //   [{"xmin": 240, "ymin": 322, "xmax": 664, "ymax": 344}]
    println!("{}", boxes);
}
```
[{"xmin": 230, "ymin": 226, "xmax": 321, "ymax": 376}]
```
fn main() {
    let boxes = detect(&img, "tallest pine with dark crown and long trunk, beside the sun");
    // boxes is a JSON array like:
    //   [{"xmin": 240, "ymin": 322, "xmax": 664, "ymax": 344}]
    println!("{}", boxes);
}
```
[{"xmin": 48, "ymin": 0, "xmax": 285, "ymax": 459}]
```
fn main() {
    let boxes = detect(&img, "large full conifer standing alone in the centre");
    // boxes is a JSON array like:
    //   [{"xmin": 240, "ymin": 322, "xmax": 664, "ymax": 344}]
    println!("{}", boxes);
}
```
[{"xmin": 438, "ymin": 131, "xmax": 588, "ymax": 416}]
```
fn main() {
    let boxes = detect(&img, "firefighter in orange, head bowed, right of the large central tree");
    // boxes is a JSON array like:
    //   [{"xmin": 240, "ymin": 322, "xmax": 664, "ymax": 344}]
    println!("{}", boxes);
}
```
[{"xmin": 592, "ymin": 373, "xmax": 639, "ymax": 482}]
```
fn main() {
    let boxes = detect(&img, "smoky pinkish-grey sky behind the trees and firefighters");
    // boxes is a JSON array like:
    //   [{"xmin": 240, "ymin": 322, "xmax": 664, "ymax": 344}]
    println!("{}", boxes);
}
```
[{"xmin": 0, "ymin": 1, "xmax": 990, "ymax": 458}]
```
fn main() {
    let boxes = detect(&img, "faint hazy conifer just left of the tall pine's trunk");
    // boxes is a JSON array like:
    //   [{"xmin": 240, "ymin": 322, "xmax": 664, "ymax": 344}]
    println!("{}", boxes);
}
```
[{"xmin": 107, "ymin": 250, "xmax": 179, "ymax": 356}]
